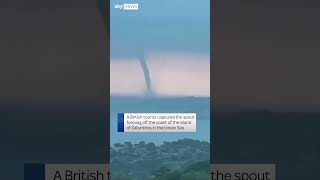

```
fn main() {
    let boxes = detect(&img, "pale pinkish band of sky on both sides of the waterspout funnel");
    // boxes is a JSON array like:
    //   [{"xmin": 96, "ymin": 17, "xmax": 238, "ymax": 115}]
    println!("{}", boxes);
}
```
[{"xmin": 110, "ymin": 53, "xmax": 210, "ymax": 96}]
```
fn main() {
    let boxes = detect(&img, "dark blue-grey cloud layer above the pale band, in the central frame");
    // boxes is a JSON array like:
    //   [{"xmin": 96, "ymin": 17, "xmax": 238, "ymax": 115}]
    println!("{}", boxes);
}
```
[{"xmin": 110, "ymin": 0, "xmax": 210, "ymax": 59}]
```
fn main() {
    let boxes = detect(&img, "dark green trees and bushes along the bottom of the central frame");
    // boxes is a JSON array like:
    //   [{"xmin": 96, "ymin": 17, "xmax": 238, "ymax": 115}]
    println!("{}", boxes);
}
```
[{"xmin": 110, "ymin": 138, "xmax": 210, "ymax": 180}]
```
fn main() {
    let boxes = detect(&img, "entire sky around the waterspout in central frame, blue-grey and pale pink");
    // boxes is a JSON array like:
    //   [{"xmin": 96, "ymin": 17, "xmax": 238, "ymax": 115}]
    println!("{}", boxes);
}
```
[{"xmin": 110, "ymin": 0, "xmax": 210, "ymax": 97}]
